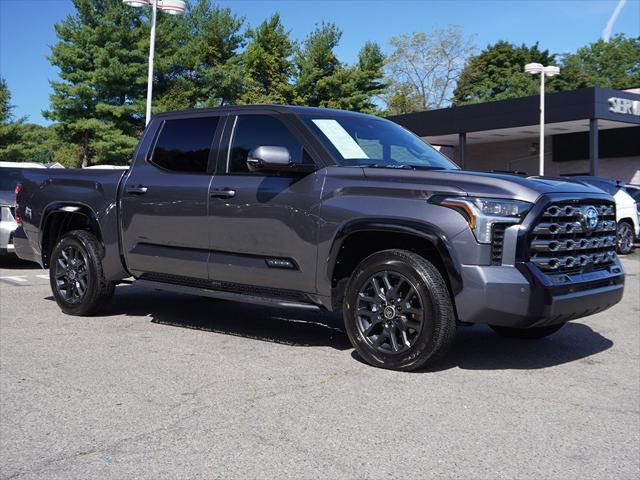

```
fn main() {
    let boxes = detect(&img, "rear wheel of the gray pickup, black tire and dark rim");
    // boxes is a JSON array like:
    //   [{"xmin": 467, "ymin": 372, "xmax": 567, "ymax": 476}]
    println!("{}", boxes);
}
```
[{"xmin": 49, "ymin": 230, "xmax": 115, "ymax": 316}]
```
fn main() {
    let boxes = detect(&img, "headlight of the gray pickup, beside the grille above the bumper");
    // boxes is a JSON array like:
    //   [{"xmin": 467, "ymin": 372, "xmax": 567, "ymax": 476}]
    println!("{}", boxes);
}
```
[{"xmin": 433, "ymin": 197, "xmax": 533, "ymax": 243}]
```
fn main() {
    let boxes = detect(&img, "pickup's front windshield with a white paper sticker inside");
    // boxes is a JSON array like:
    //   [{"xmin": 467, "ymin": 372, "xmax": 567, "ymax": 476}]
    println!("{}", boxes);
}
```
[{"xmin": 301, "ymin": 115, "xmax": 458, "ymax": 170}]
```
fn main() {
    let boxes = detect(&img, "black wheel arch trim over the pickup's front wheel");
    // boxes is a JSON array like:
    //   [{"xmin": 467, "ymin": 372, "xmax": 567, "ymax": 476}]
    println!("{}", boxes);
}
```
[{"xmin": 326, "ymin": 217, "xmax": 462, "ymax": 295}]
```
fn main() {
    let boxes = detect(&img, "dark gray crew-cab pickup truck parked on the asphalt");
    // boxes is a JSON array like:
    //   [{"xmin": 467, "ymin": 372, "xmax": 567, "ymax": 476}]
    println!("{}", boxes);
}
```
[{"xmin": 15, "ymin": 106, "xmax": 624, "ymax": 370}]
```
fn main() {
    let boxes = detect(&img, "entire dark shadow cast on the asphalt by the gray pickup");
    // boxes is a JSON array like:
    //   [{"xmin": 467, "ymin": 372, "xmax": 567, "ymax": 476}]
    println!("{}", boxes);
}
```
[{"xmin": 49, "ymin": 286, "xmax": 613, "ymax": 373}]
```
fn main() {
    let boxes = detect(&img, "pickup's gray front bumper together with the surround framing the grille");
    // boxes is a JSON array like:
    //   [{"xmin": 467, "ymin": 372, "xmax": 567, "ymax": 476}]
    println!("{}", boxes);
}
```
[{"xmin": 455, "ymin": 194, "xmax": 624, "ymax": 328}]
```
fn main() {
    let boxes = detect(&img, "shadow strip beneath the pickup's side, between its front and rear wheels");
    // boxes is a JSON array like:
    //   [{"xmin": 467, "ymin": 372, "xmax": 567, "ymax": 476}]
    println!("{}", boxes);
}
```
[{"xmin": 101, "ymin": 286, "xmax": 351, "ymax": 350}]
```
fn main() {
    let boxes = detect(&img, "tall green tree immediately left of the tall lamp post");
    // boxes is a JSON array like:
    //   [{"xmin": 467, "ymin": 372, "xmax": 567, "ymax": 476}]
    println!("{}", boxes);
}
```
[{"xmin": 44, "ymin": 0, "xmax": 148, "ymax": 167}]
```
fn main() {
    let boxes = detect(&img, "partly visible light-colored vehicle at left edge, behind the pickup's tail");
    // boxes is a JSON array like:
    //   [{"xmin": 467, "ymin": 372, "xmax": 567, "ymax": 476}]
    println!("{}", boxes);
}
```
[{"xmin": 0, "ymin": 162, "xmax": 44, "ymax": 255}]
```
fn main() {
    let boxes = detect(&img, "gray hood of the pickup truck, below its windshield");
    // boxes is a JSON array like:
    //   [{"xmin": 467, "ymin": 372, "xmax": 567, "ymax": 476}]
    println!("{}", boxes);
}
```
[{"xmin": 363, "ymin": 168, "xmax": 603, "ymax": 203}]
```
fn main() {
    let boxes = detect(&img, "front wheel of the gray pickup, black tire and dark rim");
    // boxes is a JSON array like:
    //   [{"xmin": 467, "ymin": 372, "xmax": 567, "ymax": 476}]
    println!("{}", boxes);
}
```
[{"xmin": 343, "ymin": 250, "xmax": 456, "ymax": 371}]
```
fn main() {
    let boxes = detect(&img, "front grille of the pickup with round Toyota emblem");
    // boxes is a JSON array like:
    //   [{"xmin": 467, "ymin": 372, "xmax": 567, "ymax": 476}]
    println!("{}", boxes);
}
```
[{"xmin": 530, "ymin": 202, "xmax": 616, "ymax": 273}]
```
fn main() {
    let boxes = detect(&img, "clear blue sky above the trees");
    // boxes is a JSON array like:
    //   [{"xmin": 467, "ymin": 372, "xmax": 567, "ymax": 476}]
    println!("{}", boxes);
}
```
[{"xmin": 0, "ymin": 0, "xmax": 640, "ymax": 124}]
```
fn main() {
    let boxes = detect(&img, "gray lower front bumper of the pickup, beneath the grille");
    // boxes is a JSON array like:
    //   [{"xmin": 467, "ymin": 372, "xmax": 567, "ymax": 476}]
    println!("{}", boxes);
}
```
[{"xmin": 456, "ymin": 260, "xmax": 624, "ymax": 328}]
